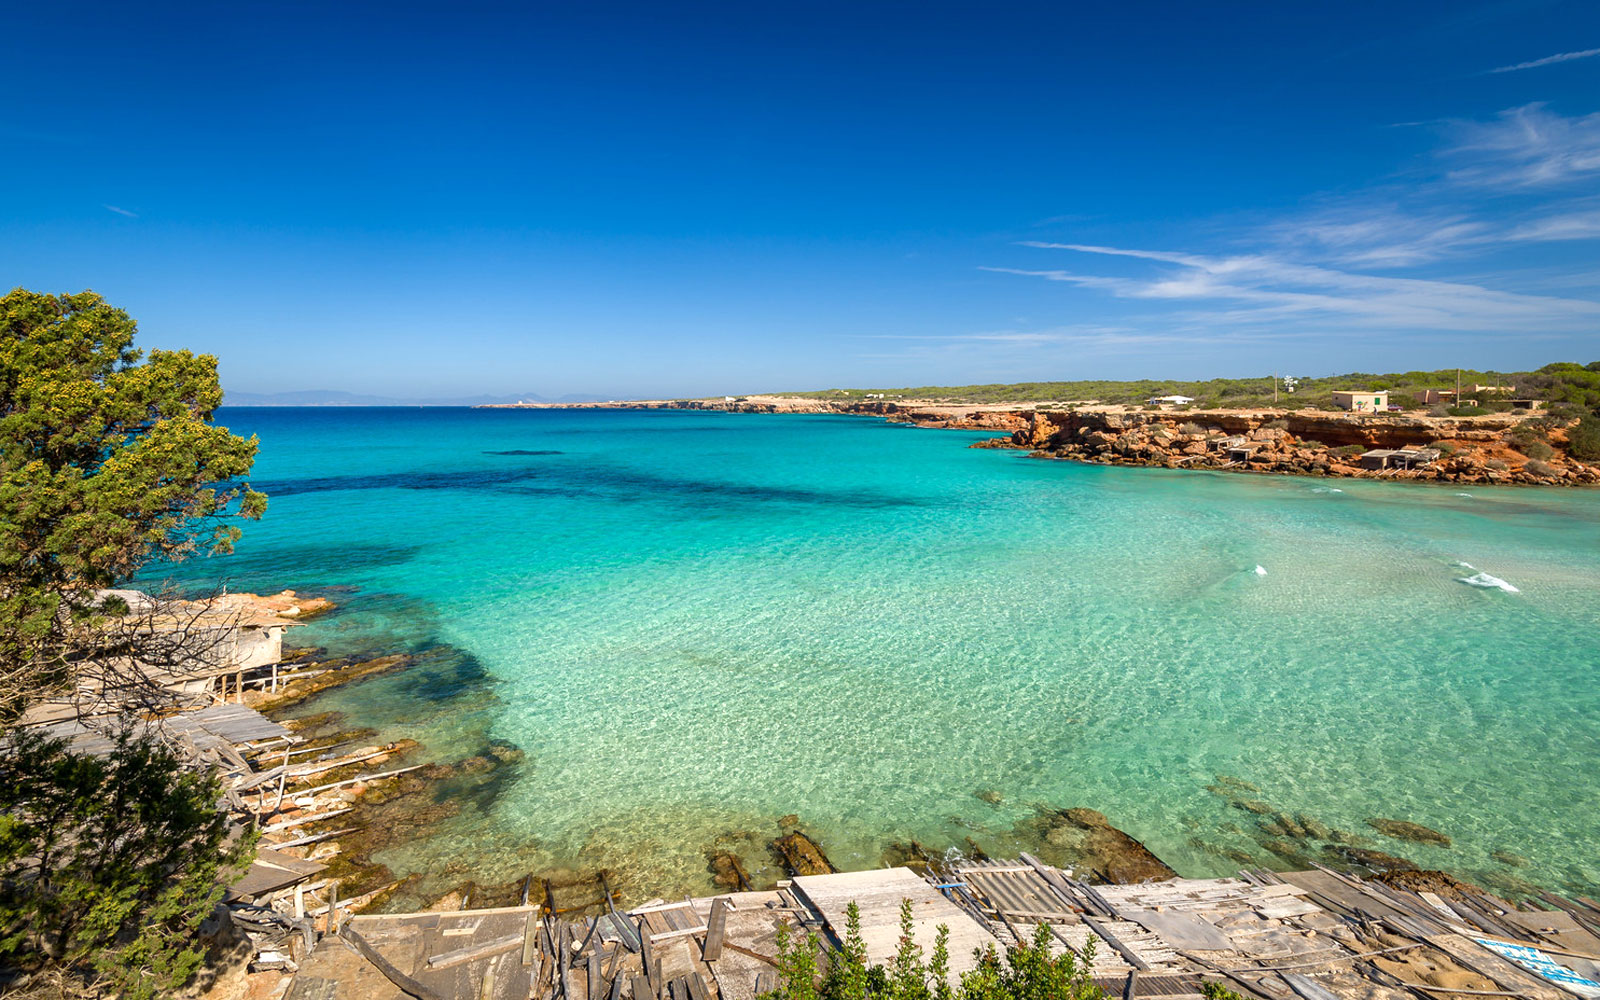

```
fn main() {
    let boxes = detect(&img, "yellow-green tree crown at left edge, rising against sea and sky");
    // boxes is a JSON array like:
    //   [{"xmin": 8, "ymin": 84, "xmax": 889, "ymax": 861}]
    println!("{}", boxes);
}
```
[{"xmin": 0, "ymin": 288, "xmax": 266, "ymax": 723}]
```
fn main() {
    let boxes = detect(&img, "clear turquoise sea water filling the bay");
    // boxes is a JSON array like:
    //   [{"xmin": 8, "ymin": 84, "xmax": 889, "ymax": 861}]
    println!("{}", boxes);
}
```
[{"xmin": 147, "ymin": 410, "xmax": 1600, "ymax": 893}]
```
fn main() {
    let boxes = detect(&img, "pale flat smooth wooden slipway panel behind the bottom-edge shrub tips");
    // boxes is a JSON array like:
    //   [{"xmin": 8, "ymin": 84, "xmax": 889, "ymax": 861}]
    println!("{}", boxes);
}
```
[{"xmin": 794, "ymin": 869, "xmax": 1005, "ymax": 973}]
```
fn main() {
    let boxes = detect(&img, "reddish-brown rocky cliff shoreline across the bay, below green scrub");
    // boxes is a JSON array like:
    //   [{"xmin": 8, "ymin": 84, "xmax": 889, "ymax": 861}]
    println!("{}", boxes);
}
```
[{"xmin": 489, "ymin": 397, "xmax": 1600, "ymax": 486}]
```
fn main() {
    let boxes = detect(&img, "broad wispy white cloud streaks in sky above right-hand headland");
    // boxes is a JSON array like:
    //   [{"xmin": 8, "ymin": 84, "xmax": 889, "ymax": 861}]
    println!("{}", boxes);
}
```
[{"xmin": 982, "ymin": 104, "xmax": 1600, "ymax": 349}]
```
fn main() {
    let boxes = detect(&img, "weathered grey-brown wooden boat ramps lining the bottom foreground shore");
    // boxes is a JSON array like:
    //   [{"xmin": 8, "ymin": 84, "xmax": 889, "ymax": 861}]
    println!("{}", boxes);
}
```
[{"xmin": 275, "ymin": 854, "xmax": 1600, "ymax": 1000}]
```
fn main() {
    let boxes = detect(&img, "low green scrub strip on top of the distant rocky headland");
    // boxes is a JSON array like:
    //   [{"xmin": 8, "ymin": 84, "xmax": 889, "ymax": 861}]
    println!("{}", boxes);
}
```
[{"xmin": 784, "ymin": 362, "xmax": 1600, "ymax": 416}]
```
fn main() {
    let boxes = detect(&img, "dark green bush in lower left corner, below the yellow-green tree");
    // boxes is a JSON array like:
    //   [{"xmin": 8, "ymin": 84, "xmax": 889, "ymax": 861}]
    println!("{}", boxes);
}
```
[{"xmin": 0, "ymin": 730, "xmax": 256, "ymax": 1000}]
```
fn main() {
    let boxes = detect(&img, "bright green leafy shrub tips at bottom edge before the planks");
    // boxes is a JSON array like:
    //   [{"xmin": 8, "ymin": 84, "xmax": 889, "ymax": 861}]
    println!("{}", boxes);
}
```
[{"xmin": 766, "ymin": 899, "xmax": 1106, "ymax": 1000}]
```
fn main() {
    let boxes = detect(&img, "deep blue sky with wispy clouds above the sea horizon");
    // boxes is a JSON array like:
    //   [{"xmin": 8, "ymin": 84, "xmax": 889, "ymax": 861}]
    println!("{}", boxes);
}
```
[{"xmin": 0, "ymin": 0, "xmax": 1600, "ymax": 397}]
